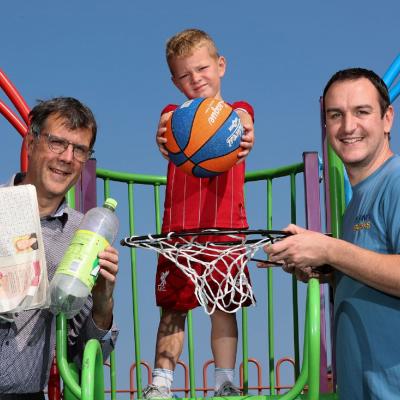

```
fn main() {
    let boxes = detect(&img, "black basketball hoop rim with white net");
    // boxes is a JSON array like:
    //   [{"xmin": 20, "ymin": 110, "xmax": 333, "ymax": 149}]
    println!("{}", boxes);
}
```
[{"xmin": 121, "ymin": 229, "xmax": 288, "ymax": 314}]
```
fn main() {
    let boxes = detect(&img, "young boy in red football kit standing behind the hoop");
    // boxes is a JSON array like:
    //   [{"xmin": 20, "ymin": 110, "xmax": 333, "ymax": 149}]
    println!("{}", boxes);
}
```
[{"xmin": 143, "ymin": 29, "xmax": 254, "ymax": 399}]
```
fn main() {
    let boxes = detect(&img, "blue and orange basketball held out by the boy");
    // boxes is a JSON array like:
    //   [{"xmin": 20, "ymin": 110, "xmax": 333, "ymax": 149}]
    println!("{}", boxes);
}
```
[{"xmin": 165, "ymin": 98, "xmax": 243, "ymax": 178}]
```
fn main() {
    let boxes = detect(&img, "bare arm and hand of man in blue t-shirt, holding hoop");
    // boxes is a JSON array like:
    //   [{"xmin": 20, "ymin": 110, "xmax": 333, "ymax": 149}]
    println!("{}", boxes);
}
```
[{"xmin": 265, "ymin": 225, "xmax": 400, "ymax": 297}]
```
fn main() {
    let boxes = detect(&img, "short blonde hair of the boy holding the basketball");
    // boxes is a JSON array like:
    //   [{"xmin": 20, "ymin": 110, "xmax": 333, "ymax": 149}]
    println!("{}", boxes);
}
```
[{"xmin": 166, "ymin": 29, "xmax": 219, "ymax": 73}]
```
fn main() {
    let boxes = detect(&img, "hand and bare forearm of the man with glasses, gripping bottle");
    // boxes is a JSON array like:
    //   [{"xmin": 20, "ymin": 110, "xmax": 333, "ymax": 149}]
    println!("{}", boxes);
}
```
[{"xmin": 92, "ymin": 246, "xmax": 118, "ymax": 330}]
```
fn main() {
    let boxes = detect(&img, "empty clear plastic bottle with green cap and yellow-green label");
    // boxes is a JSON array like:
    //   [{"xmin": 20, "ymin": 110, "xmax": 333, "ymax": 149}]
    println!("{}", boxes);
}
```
[{"xmin": 50, "ymin": 198, "xmax": 119, "ymax": 318}]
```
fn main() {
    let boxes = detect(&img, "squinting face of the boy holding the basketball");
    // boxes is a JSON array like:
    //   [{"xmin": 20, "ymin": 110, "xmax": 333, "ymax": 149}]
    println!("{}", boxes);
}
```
[{"xmin": 170, "ymin": 44, "xmax": 226, "ymax": 99}]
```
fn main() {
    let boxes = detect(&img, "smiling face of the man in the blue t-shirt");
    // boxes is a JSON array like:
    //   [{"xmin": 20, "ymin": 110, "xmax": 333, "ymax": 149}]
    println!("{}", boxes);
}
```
[{"xmin": 325, "ymin": 78, "xmax": 393, "ymax": 184}]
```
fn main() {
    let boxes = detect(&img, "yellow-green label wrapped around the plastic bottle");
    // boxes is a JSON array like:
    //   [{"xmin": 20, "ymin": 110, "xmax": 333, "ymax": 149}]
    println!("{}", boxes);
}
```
[{"xmin": 56, "ymin": 229, "xmax": 109, "ymax": 290}]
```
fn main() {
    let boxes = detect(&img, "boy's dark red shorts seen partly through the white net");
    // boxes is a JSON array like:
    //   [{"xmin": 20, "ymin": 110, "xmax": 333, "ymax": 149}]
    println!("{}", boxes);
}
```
[{"xmin": 155, "ymin": 236, "xmax": 254, "ymax": 311}]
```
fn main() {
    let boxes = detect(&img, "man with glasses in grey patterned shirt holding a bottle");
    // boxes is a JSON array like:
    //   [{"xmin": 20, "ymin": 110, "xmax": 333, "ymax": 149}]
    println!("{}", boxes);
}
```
[{"xmin": 0, "ymin": 97, "xmax": 118, "ymax": 400}]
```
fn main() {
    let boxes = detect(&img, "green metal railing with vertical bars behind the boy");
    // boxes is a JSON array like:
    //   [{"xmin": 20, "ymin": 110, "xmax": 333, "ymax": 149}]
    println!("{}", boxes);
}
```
[{"xmin": 57, "ymin": 163, "xmax": 320, "ymax": 399}]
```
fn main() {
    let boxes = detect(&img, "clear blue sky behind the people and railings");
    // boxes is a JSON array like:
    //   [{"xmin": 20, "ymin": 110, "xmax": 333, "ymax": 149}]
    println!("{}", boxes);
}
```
[{"xmin": 0, "ymin": 0, "xmax": 400, "ymax": 394}]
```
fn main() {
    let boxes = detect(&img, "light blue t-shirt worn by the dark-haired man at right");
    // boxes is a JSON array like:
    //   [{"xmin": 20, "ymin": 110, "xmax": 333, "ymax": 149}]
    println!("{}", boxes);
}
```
[{"xmin": 335, "ymin": 155, "xmax": 400, "ymax": 400}]
